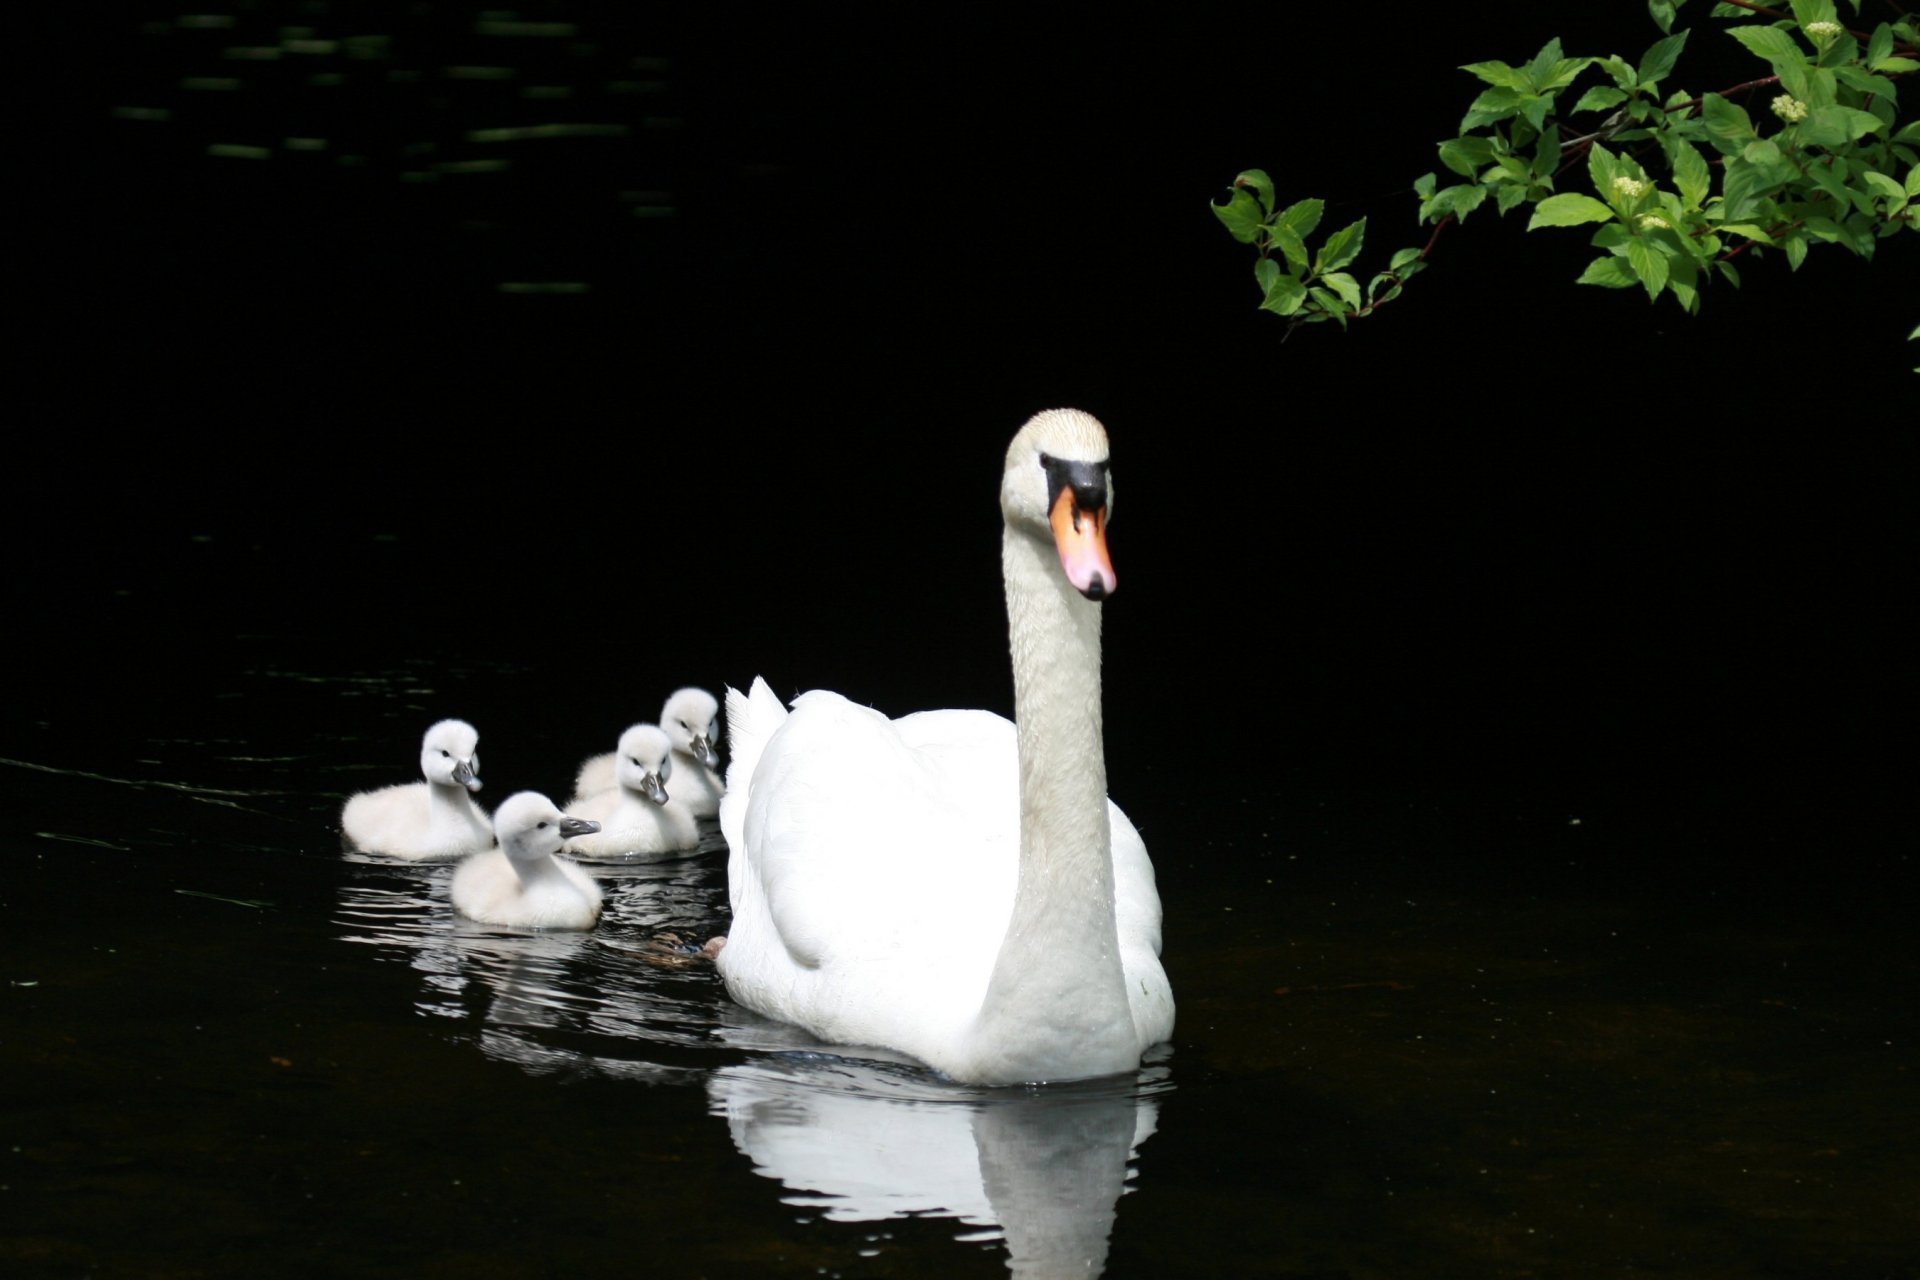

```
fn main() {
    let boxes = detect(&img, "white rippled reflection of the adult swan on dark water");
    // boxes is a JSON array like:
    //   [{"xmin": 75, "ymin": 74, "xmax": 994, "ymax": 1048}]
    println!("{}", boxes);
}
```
[{"xmin": 708, "ymin": 1054, "xmax": 1167, "ymax": 1276}]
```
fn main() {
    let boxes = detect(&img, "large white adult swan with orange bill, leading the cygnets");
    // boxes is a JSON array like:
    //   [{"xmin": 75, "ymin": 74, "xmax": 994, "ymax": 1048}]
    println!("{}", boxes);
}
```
[{"xmin": 716, "ymin": 409, "xmax": 1173, "ymax": 1084}]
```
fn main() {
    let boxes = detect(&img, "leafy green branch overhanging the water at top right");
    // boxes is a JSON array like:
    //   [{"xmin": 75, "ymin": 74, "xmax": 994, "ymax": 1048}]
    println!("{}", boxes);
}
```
[{"xmin": 1213, "ymin": 0, "xmax": 1920, "ymax": 334}]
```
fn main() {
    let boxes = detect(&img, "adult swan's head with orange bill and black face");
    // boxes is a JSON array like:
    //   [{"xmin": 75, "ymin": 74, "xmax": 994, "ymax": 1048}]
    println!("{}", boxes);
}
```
[{"xmin": 1000, "ymin": 409, "xmax": 1117, "ymax": 601}]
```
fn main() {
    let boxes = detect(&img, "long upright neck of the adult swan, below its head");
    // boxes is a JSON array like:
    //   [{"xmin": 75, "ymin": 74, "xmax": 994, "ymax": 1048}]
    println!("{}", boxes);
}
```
[{"xmin": 977, "ymin": 526, "xmax": 1139, "ymax": 1080}]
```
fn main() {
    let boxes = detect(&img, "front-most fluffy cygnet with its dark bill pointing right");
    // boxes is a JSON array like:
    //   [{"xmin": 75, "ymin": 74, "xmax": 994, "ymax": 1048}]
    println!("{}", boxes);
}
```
[{"xmin": 453, "ymin": 791, "xmax": 601, "ymax": 929}]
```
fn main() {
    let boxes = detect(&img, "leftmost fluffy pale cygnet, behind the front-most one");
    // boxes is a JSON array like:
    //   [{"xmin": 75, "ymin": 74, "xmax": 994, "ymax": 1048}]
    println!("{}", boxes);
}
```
[{"xmin": 340, "ymin": 720, "xmax": 493, "ymax": 862}]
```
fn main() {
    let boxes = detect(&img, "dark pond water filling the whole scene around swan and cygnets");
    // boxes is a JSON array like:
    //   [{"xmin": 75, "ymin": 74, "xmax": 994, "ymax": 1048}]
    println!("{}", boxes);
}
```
[{"xmin": 0, "ymin": 0, "xmax": 1920, "ymax": 1280}]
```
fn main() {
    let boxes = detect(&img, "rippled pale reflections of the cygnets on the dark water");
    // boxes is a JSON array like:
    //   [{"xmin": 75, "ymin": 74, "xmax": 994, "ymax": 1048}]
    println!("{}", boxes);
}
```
[{"xmin": 336, "ymin": 864, "xmax": 714, "ymax": 1080}]
